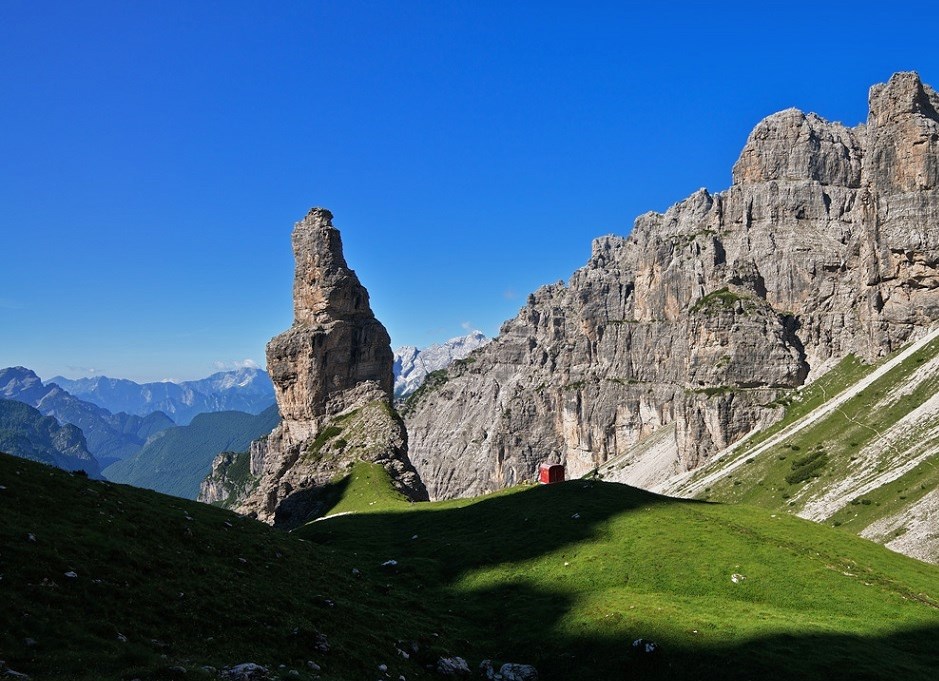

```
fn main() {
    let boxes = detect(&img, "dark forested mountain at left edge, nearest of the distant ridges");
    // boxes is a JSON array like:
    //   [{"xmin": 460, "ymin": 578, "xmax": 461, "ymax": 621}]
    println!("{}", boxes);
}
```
[{"xmin": 0, "ymin": 399, "xmax": 101, "ymax": 478}]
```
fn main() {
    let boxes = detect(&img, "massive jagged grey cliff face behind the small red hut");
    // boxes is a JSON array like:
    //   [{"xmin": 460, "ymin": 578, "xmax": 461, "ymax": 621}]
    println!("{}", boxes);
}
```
[{"xmin": 406, "ymin": 73, "xmax": 939, "ymax": 498}]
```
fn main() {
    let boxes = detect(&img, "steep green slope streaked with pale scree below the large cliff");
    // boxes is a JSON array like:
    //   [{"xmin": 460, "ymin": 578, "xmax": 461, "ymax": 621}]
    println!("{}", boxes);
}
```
[{"xmin": 667, "ymin": 326, "xmax": 939, "ymax": 562}]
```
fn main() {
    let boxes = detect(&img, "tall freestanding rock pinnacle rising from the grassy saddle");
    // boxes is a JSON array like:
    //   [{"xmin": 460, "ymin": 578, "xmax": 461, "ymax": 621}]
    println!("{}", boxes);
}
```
[{"xmin": 206, "ymin": 208, "xmax": 427, "ymax": 526}]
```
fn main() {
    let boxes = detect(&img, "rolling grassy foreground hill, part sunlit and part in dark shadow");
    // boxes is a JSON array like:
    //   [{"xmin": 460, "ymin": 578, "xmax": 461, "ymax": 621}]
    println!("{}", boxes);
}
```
[{"xmin": 0, "ymin": 456, "xmax": 939, "ymax": 681}]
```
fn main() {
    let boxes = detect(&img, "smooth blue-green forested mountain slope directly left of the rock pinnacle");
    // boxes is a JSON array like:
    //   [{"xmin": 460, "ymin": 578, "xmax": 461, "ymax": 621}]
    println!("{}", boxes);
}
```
[{"xmin": 104, "ymin": 405, "xmax": 280, "ymax": 499}]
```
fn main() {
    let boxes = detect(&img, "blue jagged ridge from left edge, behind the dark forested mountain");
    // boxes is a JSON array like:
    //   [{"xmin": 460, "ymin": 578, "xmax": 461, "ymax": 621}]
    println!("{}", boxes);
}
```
[{"xmin": 0, "ymin": 367, "xmax": 175, "ymax": 466}]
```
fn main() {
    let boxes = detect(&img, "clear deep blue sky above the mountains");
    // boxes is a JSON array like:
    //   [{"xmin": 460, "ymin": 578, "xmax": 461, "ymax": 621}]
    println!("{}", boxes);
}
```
[{"xmin": 0, "ymin": 0, "xmax": 939, "ymax": 380}]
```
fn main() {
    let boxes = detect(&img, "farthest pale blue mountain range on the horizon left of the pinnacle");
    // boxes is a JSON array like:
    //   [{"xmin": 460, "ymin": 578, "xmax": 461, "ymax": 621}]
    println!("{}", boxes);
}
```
[{"xmin": 50, "ymin": 368, "xmax": 274, "ymax": 425}]
